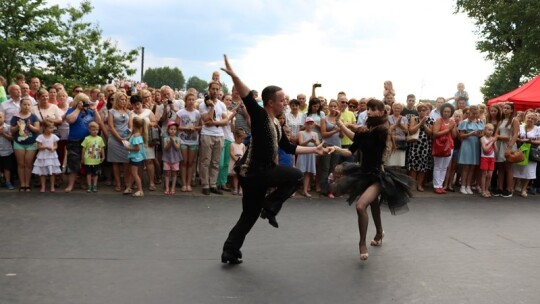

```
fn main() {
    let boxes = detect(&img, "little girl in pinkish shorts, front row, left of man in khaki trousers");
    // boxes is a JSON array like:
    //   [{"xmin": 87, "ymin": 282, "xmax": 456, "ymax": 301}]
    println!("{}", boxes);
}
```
[{"xmin": 163, "ymin": 120, "xmax": 182, "ymax": 195}]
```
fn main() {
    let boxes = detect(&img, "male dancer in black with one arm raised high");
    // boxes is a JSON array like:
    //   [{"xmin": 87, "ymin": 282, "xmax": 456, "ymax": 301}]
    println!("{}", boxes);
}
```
[{"xmin": 221, "ymin": 55, "xmax": 334, "ymax": 264}]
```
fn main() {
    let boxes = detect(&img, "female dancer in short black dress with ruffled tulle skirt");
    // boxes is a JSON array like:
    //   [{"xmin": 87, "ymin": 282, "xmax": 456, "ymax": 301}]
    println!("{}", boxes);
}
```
[{"xmin": 333, "ymin": 99, "xmax": 412, "ymax": 261}]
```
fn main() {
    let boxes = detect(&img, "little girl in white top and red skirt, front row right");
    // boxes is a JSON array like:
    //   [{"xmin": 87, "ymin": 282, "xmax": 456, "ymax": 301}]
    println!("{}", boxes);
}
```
[{"xmin": 480, "ymin": 123, "xmax": 497, "ymax": 197}]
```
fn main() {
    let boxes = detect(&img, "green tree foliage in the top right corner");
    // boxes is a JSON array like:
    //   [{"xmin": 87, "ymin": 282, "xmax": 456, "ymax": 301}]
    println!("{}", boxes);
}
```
[{"xmin": 456, "ymin": 0, "xmax": 540, "ymax": 100}]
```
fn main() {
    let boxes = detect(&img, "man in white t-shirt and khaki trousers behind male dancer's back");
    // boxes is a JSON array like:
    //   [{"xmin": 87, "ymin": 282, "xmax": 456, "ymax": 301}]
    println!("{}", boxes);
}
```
[{"xmin": 199, "ymin": 81, "xmax": 230, "ymax": 195}]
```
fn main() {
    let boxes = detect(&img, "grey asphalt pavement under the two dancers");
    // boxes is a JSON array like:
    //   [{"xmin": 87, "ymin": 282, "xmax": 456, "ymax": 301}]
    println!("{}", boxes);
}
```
[{"xmin": 0, "ymin": 188, "xmax": 540, "ymax": 304}]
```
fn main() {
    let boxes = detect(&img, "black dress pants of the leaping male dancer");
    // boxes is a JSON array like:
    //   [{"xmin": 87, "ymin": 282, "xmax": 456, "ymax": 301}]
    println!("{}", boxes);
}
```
[{"xmin": 223, "ymin": 165, "xmax": 303, "ymax": 253}]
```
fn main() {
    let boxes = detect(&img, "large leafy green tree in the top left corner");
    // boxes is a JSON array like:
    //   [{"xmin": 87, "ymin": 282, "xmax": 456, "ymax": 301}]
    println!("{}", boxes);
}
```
[{"xmin": 0, "ymin": 0, "xmax": 138, "ymax": 86}]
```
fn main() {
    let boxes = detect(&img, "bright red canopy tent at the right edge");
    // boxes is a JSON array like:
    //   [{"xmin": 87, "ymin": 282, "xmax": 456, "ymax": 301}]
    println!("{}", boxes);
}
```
[{"xmin": 488, "ymin": 75, "xmax": 540, "ymax": 111}]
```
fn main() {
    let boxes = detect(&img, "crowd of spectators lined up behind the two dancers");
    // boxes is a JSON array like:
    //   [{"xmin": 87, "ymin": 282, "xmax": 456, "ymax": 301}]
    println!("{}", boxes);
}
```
[{"xmin": 0, "ymin": 72, "xmax": 540, "ymax": 198}]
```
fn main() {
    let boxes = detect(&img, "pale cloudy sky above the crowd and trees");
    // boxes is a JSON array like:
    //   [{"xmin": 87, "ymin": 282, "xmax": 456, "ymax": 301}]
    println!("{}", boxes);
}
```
[{"xmin": 50, "ymin": 0, "xmax": 493, "ymax": 103}]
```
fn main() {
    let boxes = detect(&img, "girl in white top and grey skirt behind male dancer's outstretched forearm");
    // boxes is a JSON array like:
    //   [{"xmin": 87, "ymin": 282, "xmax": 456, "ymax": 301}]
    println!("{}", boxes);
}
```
[{"xmin": 296, "ymin": 117, "xmax": 319, "ymax": 197}]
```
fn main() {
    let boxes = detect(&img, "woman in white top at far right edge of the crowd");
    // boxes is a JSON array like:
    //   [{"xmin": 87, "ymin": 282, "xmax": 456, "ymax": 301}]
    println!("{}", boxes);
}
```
[{"xmin": 512, "ymin": 113, "xmax": 540, "ymax": 197}]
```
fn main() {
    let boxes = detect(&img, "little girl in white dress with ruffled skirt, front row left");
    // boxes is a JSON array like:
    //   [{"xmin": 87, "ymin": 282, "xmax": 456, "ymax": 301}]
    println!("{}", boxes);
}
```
[{"xmin": 32, "ymin": 120, "xmax": 62, "ymax": 193}]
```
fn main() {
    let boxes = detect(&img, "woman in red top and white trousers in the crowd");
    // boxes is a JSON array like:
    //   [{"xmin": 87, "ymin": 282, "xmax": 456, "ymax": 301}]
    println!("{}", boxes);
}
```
[{"xmin": 432, "ymin": 103, "xmax": 457, "ymax": 194}]
